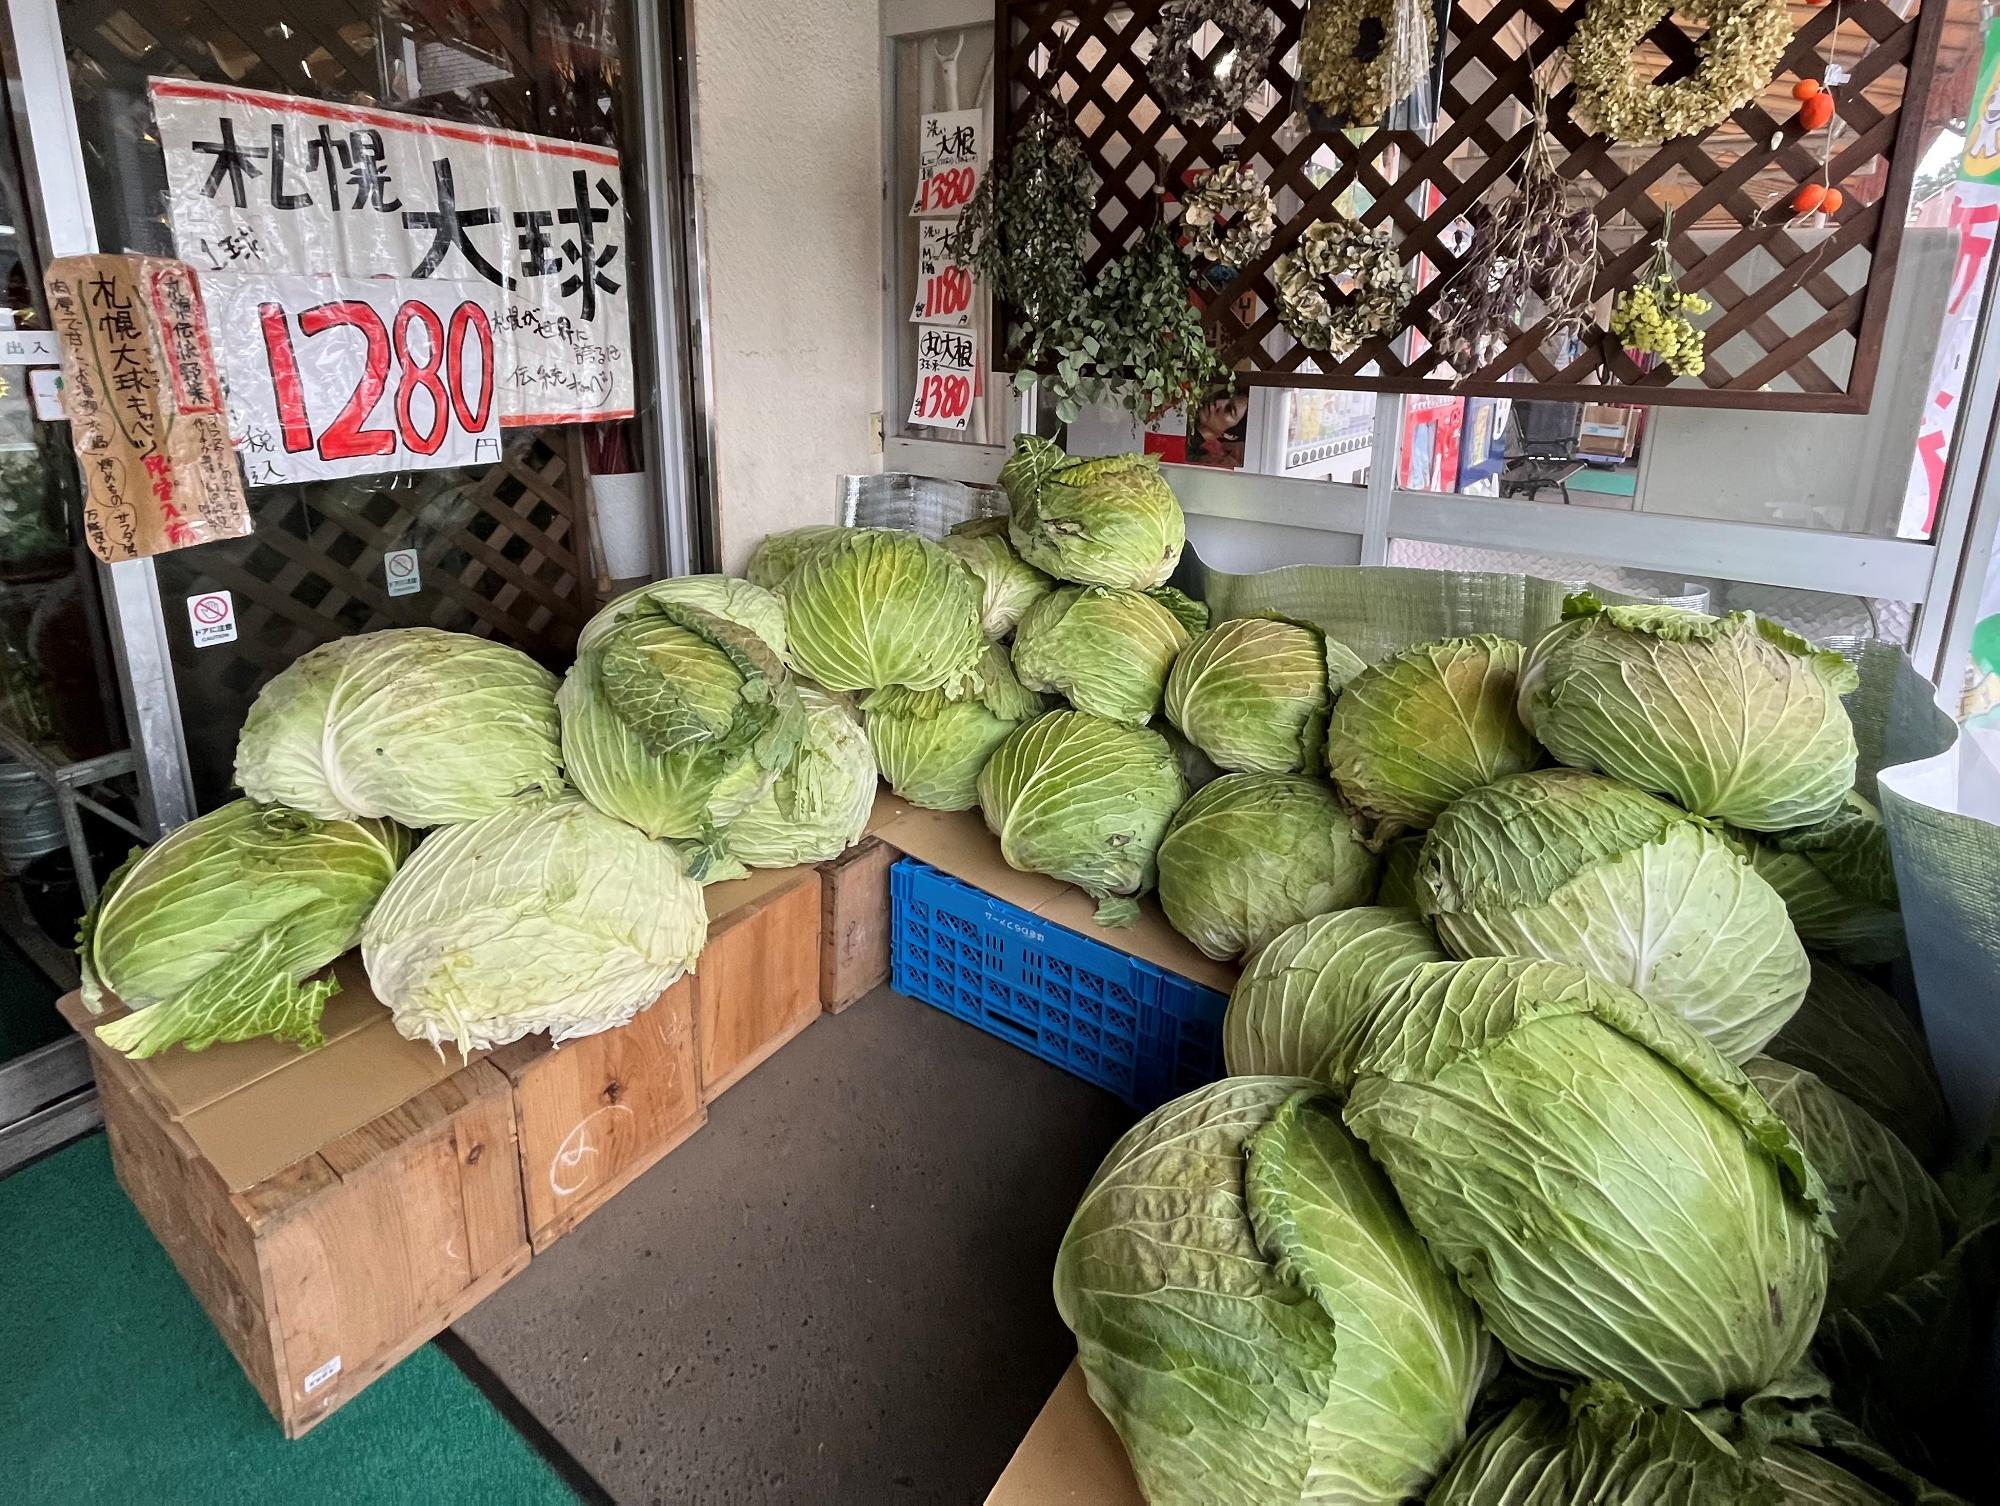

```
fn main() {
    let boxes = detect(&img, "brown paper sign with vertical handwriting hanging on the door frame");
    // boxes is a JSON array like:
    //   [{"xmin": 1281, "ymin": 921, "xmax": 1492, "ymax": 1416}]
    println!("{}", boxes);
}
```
[{"xmin": 42, "ymin": 256, "xmax": 250, "ymax": 564}]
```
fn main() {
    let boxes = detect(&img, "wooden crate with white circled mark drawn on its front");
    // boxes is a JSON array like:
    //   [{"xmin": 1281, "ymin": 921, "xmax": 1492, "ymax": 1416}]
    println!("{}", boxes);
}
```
[{"xmin": 490, "ymin": 978, "xmax": 708, "ymax": 1254}]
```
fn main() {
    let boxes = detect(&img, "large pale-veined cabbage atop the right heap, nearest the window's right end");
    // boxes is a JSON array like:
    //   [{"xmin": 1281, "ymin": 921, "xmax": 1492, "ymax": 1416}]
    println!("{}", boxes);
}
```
[{"xmin": 1520, "ymin": 594, "xmax": 1860, "ymax": 832}]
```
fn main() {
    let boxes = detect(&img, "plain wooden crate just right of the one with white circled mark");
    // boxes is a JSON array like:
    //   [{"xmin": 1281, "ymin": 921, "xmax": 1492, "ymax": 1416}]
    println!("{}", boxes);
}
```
[{"xmin": 694, "ymin": 868, "xmax": 820, "ymax": 1104}]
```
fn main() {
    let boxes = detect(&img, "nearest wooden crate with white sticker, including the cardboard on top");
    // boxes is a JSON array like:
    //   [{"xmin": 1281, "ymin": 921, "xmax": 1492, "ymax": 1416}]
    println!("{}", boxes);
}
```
[{"xmin": 60, "ymin": 958, "xmax": 528, "ymax": 1438}]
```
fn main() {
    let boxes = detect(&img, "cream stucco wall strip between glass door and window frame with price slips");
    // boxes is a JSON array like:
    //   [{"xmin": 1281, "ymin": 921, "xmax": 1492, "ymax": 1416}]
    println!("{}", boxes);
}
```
[{"xmin": 694, "ymin": 0, "xmax": 882, "ymax": 572}]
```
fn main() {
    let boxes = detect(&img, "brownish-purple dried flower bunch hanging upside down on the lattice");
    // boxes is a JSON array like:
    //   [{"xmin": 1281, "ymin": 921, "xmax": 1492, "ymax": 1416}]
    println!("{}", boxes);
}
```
[{"xmin": 1430, "ymin": 94, "xmax": 1598, "ymax": 376}]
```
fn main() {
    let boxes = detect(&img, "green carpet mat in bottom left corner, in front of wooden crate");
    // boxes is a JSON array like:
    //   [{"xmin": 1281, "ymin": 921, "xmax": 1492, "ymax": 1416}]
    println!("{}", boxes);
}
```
[{"xmin": 0, "ymin": 1134, "xmax": 576, "ymax": 1506}]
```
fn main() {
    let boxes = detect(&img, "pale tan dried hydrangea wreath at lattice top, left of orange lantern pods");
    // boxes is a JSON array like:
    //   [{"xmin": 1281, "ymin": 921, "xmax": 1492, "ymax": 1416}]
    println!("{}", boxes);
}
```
[{"xmin": 1570, "ymin": 0, "xmax": 1792, "ymax": 142}]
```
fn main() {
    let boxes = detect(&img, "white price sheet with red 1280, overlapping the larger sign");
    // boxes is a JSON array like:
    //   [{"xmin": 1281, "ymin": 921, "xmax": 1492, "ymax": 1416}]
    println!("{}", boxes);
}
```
[{"xmin": 202, "ymin": 274, "xmax": 500, "ymax": 486}]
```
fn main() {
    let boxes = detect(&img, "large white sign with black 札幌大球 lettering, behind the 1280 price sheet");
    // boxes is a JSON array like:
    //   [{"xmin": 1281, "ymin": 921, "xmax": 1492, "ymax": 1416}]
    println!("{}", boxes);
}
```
[{"xmin": 146, "ymin": 78, "xmax": 632, "ymax": 426}]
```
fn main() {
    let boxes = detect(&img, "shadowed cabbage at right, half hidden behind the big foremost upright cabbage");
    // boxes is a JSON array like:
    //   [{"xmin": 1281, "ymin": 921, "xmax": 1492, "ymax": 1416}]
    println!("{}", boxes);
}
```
[{"xmin": 1744, "ymin": 1056, "xmax": 1954, "ymax": 1308}]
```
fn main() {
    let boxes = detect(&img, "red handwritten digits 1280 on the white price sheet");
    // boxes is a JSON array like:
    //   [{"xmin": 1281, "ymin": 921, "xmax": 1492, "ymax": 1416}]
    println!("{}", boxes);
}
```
[{"xmin": 258, "ymin": 298, "xmax": 494, "ymax": 460}]
